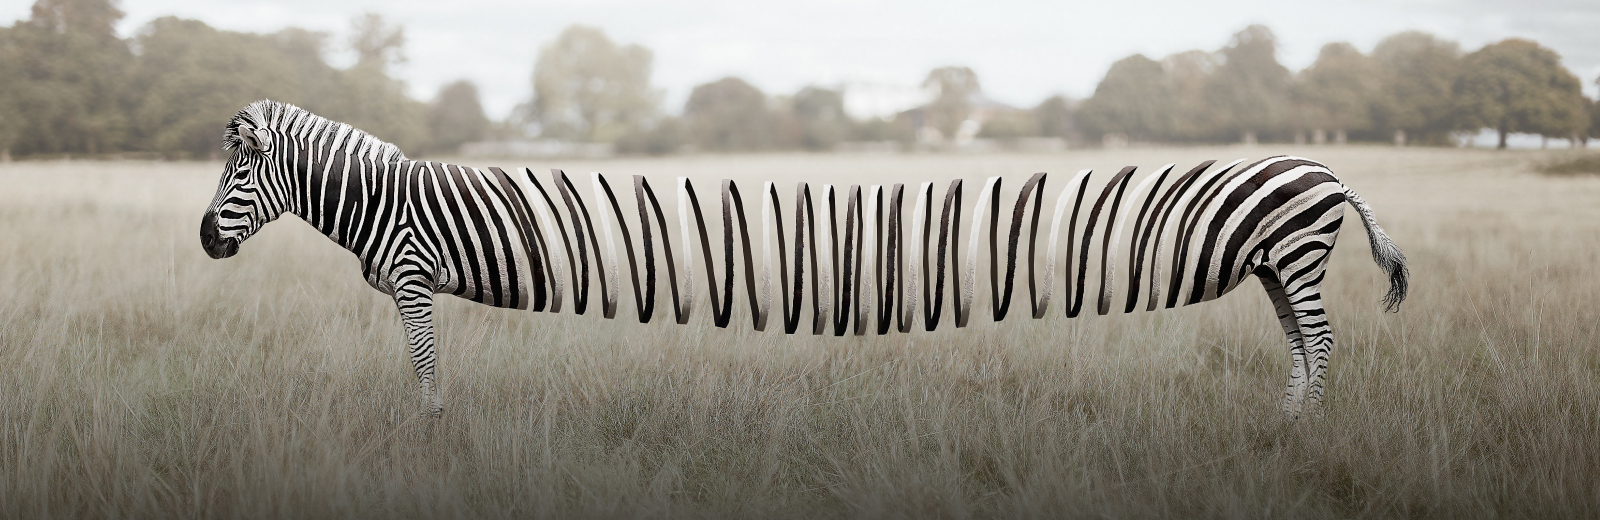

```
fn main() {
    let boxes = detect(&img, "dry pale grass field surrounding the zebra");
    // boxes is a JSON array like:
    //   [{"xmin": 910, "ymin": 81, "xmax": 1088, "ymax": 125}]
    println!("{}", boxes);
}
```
[{"xmin": 0, "ymin": 147, "xmax": 1600, "ymax": 518}]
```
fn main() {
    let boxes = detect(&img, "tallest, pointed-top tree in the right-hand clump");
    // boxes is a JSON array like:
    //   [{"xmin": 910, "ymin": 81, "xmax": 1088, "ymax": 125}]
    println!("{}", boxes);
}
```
[{"xmin": 1206, "ymin": 26, "xmax": 1290, "ymax": 141}]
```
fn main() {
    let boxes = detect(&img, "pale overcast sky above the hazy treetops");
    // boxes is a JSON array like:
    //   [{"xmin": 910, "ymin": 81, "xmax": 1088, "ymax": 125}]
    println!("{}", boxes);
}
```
[{"xmin": 0, "ymin": 0, "xmax": 1600, "ymax": 118}]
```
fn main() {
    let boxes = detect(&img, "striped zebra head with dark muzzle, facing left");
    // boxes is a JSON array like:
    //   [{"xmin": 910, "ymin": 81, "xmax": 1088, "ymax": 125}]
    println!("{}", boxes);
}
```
[{"xmin": 200, "ymin": 101, "xmax": 285, "ymax": 258}]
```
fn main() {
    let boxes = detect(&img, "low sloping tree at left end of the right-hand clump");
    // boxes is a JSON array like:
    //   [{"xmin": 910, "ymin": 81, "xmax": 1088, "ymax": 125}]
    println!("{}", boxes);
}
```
[{"xmin": 1078, "ymin": 54, "xmax": 1171, "ymax": 139}]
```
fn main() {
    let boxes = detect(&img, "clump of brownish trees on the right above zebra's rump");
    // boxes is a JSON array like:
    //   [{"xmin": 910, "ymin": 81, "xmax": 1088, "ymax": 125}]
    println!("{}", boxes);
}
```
[{"xmin": 1077, "ymin": 26, "xmax": 1600, "ymax": 147}]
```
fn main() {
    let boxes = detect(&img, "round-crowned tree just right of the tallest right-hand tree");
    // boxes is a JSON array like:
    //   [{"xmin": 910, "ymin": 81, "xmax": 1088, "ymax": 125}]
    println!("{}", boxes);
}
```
[{"xmin": 1293, "ymin": 42, "xmax": 1382, "ymax": 142}]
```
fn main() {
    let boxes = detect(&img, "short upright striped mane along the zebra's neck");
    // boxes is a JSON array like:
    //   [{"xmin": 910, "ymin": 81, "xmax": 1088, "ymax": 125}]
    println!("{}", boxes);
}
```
[{"xmin": 222, "ymin": 99, "xmax": 406, "ymax": 162}]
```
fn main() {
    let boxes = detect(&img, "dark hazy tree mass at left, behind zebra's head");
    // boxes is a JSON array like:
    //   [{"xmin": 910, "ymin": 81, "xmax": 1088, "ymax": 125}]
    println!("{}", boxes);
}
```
[{"xmin": 0, "ymin": 0, "xmax": 429, "ymax": 157}]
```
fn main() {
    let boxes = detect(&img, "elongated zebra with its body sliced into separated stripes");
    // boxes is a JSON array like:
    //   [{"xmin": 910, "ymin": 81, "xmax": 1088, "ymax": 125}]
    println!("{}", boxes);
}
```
[{"xmin": 200, "ymin": 99, "xmax": 1410, "ymax": 419}]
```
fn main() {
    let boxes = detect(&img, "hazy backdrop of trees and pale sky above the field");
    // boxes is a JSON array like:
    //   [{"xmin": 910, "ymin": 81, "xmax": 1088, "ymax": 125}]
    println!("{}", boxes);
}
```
[{"xmin": 0, "ymin": 0, "xmax": 1600, "ymax": 160}]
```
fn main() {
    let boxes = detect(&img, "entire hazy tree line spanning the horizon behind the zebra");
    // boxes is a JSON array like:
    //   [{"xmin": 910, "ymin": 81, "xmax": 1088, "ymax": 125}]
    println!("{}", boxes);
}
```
[{"xmin": 0, "ymin": 0, "xmax": 1600, "ymax": 160}]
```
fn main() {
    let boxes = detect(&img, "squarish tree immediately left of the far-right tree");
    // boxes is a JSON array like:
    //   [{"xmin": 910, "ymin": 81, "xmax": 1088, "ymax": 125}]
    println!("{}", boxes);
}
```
[{"xmin": 1373, "ymin": 30, "xmax": 1461, "ymax": 144}]
